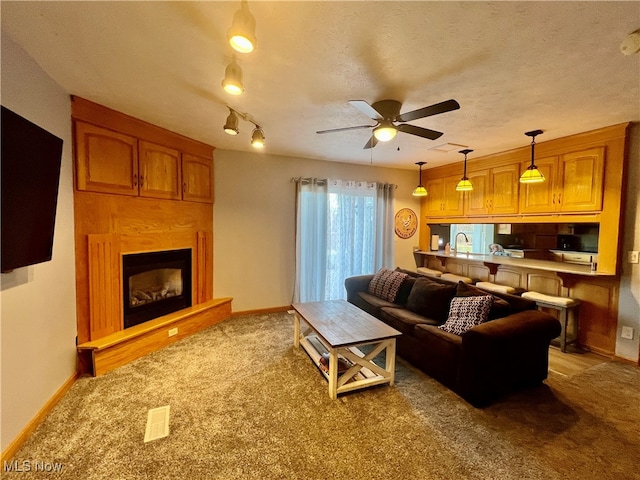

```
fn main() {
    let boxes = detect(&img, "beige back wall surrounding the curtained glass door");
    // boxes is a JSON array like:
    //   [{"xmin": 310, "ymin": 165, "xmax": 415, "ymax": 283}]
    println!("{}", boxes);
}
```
[{"xmin": 213, "ymin": 150, "xmax": 420, "ymax": 312}]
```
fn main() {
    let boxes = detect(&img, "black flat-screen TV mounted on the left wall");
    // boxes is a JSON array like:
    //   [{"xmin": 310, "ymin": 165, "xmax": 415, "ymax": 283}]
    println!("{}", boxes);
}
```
[{"xmin": 0, "ymin": 106, "xmax": 62, "ymax": 273}]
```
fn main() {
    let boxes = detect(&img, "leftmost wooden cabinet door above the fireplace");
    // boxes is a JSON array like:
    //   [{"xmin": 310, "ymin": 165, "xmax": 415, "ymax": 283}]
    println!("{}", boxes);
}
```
[{"xmin": 75, "ymin": 121, "xmax": 138, "ymax": 195}]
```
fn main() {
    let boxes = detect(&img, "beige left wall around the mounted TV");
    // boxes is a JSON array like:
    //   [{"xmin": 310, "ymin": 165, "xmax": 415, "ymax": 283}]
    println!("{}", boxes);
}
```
[{"xmin": 0, "ymin": 33, "xmax": 76, "ymax": 451}]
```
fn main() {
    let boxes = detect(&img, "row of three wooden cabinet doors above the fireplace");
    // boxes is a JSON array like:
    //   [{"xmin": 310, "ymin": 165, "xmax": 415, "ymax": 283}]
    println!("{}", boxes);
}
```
[{"xmin": 75, "ymin": 121, "xmax": 213, "ymax": 203}]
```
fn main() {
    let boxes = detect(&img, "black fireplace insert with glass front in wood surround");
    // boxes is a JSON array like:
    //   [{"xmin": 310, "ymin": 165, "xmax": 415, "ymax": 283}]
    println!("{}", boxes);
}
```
[{"xmin": 122, "ymin": 249, "xmax": 191, "ymax": 328}]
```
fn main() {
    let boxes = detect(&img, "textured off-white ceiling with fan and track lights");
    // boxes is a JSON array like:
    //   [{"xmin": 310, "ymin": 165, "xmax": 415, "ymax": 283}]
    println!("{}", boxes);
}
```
[{"xmin": 1, "ymin": 0, "xmax": 640, "ymax": 168}]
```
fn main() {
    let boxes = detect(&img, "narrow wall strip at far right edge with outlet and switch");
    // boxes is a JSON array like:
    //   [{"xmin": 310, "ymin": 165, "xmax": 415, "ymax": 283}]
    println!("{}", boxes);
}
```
[{"xmin": 616, "ymin": 125, "xmax": 640, "ymax": 362}]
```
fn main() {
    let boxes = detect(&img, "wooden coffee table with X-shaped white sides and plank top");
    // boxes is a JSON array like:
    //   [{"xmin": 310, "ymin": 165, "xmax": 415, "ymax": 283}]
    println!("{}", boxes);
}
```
[{"xmin": 293, "ymin": 300, "xmax": 401, "ymax": 400}]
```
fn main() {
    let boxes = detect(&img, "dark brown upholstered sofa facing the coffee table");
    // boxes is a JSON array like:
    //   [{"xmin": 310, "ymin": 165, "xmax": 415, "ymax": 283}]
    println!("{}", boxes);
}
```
[{"xmin": 345, "ymin": 271, "xmax": 561, "ymax": 407}]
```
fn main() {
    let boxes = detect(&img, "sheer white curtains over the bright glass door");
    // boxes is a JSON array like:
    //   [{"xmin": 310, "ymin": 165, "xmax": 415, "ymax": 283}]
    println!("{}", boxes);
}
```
[{"xmin": 294, "ymin": 179, "xmax": 395, "ymax": 302}]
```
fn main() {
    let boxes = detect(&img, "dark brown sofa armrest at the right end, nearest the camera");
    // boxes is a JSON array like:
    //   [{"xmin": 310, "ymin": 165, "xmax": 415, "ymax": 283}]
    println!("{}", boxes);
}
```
[{"xmin": 458, "ymin": 310, "xmax": 561, "ymax": 406}]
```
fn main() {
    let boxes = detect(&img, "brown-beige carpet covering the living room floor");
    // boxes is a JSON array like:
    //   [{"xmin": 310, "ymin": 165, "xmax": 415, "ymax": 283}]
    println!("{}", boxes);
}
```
[{"xmin": 2, "ymin": 314, "xmax": 640, "ymax": 480}]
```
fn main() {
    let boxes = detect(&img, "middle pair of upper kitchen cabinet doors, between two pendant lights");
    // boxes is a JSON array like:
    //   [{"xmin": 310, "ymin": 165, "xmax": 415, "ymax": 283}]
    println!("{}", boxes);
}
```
[{"xmin": 464, "ymin": 164, "xmax": 520, "ymax": 215}]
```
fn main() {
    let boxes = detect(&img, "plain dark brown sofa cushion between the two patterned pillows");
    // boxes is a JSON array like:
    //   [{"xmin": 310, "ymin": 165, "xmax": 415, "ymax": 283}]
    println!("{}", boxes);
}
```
[{"xmin": 407, "ymin": 278, "xmax": 456, "ymax": 323}]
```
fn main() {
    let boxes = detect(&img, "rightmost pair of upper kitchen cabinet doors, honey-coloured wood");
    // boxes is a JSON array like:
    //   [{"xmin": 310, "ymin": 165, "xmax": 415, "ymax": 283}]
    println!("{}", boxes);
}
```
[{"xmin": 520, "ymin": 147, "xmax": 604, "ymax": 213}]
